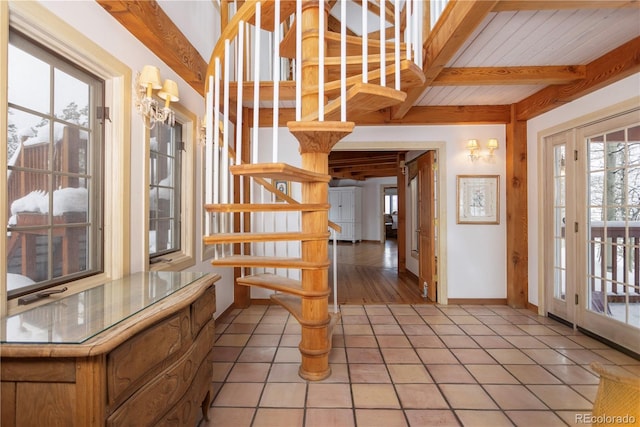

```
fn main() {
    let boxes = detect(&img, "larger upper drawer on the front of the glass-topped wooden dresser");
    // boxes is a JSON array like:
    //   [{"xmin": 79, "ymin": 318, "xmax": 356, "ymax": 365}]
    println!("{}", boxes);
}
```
[{"xmin": 107, "ymin": 307, "xmax": 191, "ymax": 405}]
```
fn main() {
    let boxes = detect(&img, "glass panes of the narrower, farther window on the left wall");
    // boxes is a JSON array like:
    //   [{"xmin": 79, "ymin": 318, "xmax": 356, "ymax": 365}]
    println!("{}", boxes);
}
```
[{"xmin": 149, "ymin": 122, "xmax": 183, "ymax": 263}]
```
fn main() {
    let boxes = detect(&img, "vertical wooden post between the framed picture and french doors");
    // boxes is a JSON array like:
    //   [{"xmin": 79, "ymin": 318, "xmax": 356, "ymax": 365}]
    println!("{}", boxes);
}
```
[{"xmin": 506, "ymin": 104, "xmax": 529, "ymax": 308}]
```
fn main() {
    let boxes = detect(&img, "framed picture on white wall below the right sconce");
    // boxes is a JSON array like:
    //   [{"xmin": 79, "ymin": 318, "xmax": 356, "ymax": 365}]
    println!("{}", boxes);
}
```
[{"xmin": 456, "ymin": 175, "xmax": 500, "ymax": 224}]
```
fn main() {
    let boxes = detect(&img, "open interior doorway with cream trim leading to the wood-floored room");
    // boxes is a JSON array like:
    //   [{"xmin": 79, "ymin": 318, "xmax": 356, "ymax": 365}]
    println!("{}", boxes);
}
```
[{"xmin": 330, "ymin": 142, "xmax": 447, "ymax": 304}]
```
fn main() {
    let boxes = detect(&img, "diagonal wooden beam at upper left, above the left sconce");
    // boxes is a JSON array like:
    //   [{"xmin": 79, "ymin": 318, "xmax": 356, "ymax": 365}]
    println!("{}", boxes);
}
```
[{"xmin": 96, "ymin": 0, "xmax": 207, "ymax": 96}]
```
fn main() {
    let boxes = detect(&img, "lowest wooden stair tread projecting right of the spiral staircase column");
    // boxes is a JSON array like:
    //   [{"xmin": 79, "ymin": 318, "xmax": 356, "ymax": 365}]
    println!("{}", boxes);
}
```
[{"xmin": 302, "ymin": 83, "xmax": 407, "ymax": 121}]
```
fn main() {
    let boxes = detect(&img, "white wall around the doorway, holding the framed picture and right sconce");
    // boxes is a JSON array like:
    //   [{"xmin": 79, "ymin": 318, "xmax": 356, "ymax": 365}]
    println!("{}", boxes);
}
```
[{"xmin": 260, "ymin": 125, "xmax": 506, "ymax": 301}]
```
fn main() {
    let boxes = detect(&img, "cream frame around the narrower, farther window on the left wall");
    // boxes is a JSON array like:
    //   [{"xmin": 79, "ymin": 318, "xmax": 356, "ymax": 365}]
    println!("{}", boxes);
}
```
[{"xmin": 141, "ymin": 103, "xmax": 199, "ymax": 271}]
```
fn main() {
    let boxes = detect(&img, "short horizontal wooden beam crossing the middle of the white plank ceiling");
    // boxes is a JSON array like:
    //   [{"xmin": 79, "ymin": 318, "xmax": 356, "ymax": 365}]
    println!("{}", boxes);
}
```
[{"xmin": 432, "ymin": 65, "xmax": 587, "ymax": 86}]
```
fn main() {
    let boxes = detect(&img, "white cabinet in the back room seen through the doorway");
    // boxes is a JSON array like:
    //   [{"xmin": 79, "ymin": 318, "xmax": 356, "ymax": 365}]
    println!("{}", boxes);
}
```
[{"xmin": 329, "ymin": 187, "xmax": 362, "ymax": 243}]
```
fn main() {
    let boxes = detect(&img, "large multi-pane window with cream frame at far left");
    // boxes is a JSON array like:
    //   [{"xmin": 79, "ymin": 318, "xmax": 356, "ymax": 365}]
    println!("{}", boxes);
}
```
[{"xmin": 0, "ymin": 2, "xmax": 132, "ymax": 316}]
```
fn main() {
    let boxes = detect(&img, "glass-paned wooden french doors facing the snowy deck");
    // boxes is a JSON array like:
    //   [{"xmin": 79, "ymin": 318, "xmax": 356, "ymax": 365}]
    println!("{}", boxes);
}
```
[{"xmin": 544, "ymin": 111, "xmax": 640, "ymax": 353}]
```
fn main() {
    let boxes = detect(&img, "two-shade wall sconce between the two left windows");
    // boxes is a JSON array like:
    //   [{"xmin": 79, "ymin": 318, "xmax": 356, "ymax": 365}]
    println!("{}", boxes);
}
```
[{"xmin": 135, "ymin": 65, "xmax": 180, "ymax": 129}]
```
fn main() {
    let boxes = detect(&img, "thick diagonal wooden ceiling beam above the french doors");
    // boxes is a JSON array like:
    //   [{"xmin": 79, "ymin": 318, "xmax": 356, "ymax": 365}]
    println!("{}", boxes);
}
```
[{"xmin": 516, "ymin": 37, "xmax": 640, "ymax": 120}]
